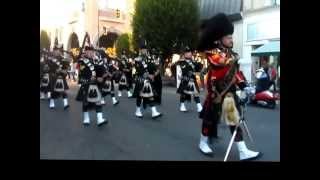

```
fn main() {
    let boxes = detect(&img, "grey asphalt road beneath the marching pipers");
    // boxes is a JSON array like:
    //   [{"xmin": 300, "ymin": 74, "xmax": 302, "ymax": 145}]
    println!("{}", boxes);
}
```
[{"xmin": 40, "ymin": 81, "xmax": 280, "ymax": 161}]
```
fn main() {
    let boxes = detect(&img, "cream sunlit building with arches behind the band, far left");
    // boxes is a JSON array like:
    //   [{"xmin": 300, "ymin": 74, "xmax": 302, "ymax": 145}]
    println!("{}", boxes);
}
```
[{"xmin": 40, "ymin": 0, "xmax": 135, "ymax": 50}]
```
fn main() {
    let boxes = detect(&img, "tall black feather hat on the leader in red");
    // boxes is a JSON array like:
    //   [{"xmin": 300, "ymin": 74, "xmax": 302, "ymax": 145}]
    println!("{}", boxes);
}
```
[{"xmin": 198, "ymin": 13, "xmax": 234, "ymax": 51}]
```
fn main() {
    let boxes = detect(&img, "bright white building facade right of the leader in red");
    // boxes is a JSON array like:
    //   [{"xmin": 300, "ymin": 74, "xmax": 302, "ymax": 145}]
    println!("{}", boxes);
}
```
[{"xmin": 239, "ymin": 0, "xmax": 280, "ymax": 82}]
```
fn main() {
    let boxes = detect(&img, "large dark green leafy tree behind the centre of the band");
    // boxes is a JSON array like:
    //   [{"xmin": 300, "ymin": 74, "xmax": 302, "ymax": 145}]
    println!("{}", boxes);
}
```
[{"xmin": 132, "ymin": 0, "xmax": 200, "ymax": 59}]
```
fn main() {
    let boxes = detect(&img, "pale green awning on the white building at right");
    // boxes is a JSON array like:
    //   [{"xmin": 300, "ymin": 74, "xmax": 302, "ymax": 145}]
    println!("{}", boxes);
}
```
[{"xmin": 251, "ymin": 41, "xmax": 280, "ymax": 56}]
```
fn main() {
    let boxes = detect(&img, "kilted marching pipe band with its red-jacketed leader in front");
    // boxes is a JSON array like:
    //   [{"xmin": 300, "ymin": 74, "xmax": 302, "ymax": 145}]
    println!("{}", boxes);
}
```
[{"xmin": 40, "ymin": 14, "xmax": 261, "ymax": 160}]
